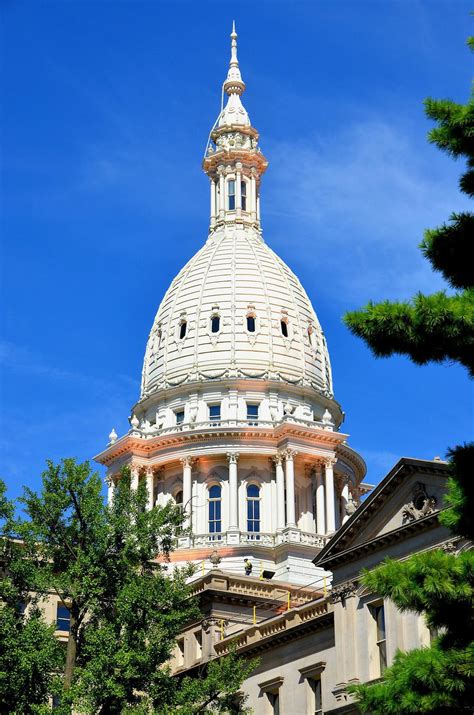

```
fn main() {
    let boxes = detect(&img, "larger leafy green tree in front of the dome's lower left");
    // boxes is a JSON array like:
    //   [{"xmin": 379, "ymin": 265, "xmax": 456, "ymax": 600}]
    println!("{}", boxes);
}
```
[{"xmin": 17, "ymin": 459, "xmax": 254, "ymax": 714}]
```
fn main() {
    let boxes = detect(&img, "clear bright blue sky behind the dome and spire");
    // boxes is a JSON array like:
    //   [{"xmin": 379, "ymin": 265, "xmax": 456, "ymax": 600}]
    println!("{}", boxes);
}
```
[{"xmin": 0, "ymin": 0, "xmax": 472, "ymax": 504}]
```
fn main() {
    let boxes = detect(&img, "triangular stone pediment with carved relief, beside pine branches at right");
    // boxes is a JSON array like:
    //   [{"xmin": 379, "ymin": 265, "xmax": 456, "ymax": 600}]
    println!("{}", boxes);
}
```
[{"xmin": 315, "ymin": 458, "xmax": 449, "ymax": 563}]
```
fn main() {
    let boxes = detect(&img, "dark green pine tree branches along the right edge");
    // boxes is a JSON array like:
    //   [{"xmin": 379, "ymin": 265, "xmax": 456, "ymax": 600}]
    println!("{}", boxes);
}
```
[{"xmin": 344, "ymin": 39, "xmax": 474, "ymax": 715}]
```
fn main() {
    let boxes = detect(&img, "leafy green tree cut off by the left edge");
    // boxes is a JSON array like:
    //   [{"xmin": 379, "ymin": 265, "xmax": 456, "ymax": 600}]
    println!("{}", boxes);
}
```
[{"xmin": 0, "ymin": 480, "xmax": 64, "ymax": 715}]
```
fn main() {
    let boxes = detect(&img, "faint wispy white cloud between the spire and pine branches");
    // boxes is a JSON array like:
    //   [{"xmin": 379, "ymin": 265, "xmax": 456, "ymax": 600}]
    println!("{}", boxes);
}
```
[{"xmin": 264, "ymin": 120, "xmax": 468, "ymax": 302}]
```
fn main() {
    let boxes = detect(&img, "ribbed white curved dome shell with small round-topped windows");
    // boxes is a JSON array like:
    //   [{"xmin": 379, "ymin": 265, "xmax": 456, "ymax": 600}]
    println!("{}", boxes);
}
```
[{"xmin": 142, "ymin": 225, "xmax": 332, "ymax": 397}]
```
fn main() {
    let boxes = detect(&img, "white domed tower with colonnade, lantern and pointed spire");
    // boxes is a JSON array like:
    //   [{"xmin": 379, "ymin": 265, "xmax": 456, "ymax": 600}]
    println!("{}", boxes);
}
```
[{"xmin": 92, "ymin": 27, "xmax": 365, "ymax": 583}]
